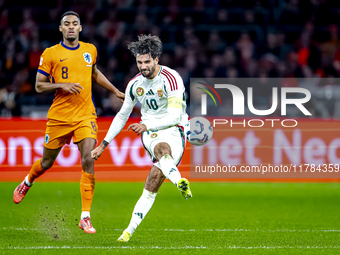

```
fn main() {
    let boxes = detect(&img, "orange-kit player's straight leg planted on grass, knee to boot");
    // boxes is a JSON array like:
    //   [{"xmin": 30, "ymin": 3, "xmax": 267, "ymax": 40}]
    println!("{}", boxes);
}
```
[{"xmin": 77, "ymin": 138, "xmax": 96, "ymax": 234}]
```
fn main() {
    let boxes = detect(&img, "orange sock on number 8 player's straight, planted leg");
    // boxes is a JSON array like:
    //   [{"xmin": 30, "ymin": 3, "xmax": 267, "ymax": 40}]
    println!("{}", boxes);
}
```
[{"xmin": 80, "ymin": 171, "xmax": 96, "ymax": 212}]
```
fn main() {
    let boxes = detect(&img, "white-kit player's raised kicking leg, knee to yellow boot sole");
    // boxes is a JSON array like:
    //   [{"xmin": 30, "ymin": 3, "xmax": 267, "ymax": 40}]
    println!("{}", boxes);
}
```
[{"xmin": 154, "ymin": 142, "xmax": 192, "ymax": 199}]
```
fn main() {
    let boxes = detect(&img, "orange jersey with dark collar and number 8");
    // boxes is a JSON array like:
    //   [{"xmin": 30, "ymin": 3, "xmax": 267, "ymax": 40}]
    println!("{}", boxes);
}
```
[{"xmin": 38, "ymin": 42, "xmax": 97, "ymax": 122}]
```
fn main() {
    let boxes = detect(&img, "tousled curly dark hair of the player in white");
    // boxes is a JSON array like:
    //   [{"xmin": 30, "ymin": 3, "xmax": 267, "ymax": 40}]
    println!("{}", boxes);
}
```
[{"xmin": 127, "ymin": 35, "xmax": 163, "ymax": 59}]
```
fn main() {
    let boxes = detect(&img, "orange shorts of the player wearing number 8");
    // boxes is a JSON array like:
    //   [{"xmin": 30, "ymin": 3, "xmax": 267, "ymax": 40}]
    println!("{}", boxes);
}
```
[{"xmin": 44, "ymin": 119, "xmax": 98, "ymax": 149}]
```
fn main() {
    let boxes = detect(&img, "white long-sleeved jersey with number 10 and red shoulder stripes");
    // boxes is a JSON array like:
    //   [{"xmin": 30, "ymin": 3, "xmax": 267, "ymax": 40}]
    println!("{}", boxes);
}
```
[{"xmin": 104, "ymin": 66, "xmax": 188, "ymax": 143}]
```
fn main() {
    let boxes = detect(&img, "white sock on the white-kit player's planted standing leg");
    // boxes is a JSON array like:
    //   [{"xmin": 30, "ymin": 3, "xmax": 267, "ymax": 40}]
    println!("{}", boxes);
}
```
[{"xmin": 126, "ymin": 189, "xmax": 157, "ymax": 235}]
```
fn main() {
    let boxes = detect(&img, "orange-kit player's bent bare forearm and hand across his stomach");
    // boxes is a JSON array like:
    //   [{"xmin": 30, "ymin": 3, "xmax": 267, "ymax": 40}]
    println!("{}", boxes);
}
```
[{"xmin": 35, "ymin": 72, "xmax": 83, "ymax": 95}]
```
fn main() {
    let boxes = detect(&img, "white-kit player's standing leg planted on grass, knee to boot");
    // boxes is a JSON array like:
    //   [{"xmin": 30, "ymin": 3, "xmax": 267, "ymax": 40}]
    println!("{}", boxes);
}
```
[{"xmin": 117, "ymin": 165, "xmax": 165, "ymax": 242}]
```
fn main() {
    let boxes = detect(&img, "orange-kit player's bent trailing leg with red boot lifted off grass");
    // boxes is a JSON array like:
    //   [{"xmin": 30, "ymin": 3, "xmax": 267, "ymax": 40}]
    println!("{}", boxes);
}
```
[{"xmin": 13, "ymin": 147, "xmax": 61, "ymax": 204}]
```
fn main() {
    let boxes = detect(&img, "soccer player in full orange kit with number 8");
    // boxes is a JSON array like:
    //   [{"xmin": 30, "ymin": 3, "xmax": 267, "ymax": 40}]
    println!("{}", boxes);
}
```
[{"xmin": 13, "ymin": 11, "xmax": 124, "ymax": 234}]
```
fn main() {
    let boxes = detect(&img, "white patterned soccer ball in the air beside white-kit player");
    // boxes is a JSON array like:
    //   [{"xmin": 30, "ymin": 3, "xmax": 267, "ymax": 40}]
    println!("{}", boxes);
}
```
[{"xmin": 184, "ymin": 117, "xmax": 213, "ymax": 145}]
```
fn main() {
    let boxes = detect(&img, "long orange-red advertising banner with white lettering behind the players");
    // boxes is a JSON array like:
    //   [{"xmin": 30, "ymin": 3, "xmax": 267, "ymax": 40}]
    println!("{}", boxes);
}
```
[{"xmin": 0, "ymin": 118, "xmax": 340, "ymax": 181}]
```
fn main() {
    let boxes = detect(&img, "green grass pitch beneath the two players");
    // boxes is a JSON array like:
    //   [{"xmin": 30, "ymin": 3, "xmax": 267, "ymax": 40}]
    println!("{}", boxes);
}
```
[{"xmin": 0, "ymin": 181, "xmax": 340, "ymax": 254}]
